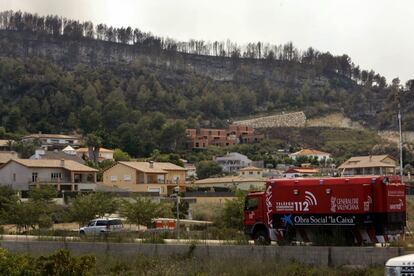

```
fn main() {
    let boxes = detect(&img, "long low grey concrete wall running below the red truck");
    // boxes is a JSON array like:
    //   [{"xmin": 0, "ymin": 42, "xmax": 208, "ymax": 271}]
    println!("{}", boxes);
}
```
[{"xmin": 1, "ymin": 241, "xmax": 403, "ymax": 266}]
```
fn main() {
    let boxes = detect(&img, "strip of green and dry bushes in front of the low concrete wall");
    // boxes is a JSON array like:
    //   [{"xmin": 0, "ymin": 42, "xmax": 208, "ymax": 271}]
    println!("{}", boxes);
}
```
[{"xmin": 0, "ymin": 247, "xmax": 384, "ymax": 276}]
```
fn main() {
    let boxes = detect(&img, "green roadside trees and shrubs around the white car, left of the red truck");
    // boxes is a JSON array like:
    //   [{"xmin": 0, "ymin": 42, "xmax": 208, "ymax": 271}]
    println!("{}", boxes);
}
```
[{"xmin": 0, "ymin": 186, "xmax": 247, "ymax": 244}]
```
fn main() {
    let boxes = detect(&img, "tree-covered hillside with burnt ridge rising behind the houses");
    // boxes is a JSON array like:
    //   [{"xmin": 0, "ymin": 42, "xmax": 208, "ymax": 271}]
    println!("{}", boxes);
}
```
[{"xmin": 0, "ymin": 12, "xmax": 414, "ymax": 156}]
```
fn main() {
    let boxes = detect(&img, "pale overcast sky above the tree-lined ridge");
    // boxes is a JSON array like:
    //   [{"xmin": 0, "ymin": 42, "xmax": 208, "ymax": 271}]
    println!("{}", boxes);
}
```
[{"xmin": 0, "ymin": 0, "xmax": 414, "ymax": 82}]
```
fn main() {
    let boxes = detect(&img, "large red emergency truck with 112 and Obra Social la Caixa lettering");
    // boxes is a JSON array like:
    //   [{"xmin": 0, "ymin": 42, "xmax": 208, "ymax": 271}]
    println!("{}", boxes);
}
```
[{"xmin": 244, "ymin": 176, "xmax": 406, "ymax": 245}]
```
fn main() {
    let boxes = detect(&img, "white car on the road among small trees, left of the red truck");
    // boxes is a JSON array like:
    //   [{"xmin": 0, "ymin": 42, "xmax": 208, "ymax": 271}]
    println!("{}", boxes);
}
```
[{"xmin": 79, "ymin": 218, "xmax": 124, "ymax": 236}]
